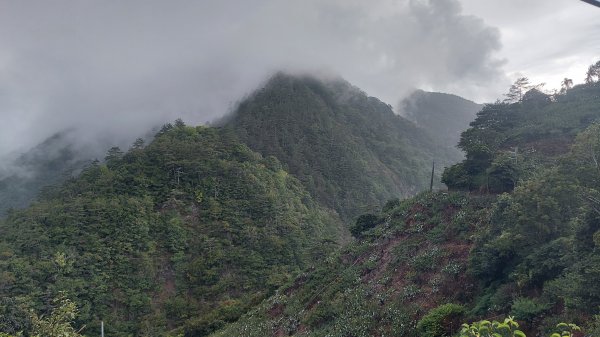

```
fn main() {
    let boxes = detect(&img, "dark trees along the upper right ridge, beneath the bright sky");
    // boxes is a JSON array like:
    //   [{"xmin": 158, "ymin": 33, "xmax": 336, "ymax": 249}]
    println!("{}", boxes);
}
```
[{"xmin": 442, "ymin": 78, "xmax": 600, "ymax": 193}]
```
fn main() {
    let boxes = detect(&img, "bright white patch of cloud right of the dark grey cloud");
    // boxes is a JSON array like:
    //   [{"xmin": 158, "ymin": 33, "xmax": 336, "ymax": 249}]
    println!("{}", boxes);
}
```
[{"xmin": 461, "ymin": 0, "xmax": 600, "ymax": 89}]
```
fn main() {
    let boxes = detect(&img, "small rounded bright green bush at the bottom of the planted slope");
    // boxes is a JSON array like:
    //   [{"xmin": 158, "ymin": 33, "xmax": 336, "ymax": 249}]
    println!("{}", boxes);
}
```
[{"xmin": 417, "ymin": 303, "xmax": 465, "ymax": 337}]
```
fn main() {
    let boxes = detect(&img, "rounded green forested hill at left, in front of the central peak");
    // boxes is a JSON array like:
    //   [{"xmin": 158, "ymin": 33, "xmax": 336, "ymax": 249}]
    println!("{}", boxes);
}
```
[{"xmin": 0, "ymin": 121, "xmax": 342, "ymax": 336}]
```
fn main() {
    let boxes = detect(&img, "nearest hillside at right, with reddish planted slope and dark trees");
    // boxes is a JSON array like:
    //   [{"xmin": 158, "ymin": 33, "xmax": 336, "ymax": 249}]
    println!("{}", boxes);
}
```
[{"xmin": 214, "ymin": 83, "xmax": 600, "ymax": 337}]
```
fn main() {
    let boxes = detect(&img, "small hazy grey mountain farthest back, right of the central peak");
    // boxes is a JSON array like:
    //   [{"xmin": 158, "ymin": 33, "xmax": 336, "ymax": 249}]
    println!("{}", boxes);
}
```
[{"xmin": 400, "ymin": 90, "xmax": 483, "ymax": 150}]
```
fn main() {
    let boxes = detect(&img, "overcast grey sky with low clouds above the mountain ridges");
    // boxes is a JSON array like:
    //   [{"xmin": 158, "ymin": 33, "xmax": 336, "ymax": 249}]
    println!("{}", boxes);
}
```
[{"xmin": 0, "ymin": 0, "xmax": 600, "ymax": 163}]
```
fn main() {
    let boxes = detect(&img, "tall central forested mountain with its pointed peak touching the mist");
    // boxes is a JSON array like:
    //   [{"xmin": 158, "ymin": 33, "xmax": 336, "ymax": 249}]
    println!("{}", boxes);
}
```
[{"xmin": 223, "ymin": 73, "xmax": 460, "ymax": 220}]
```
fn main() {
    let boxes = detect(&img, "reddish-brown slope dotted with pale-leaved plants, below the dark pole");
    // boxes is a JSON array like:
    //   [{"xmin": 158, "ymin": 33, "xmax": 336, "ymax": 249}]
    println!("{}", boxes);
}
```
[{"xmin": 213, "ymin": 192, "xmax": 489, "ymax": 337}]
